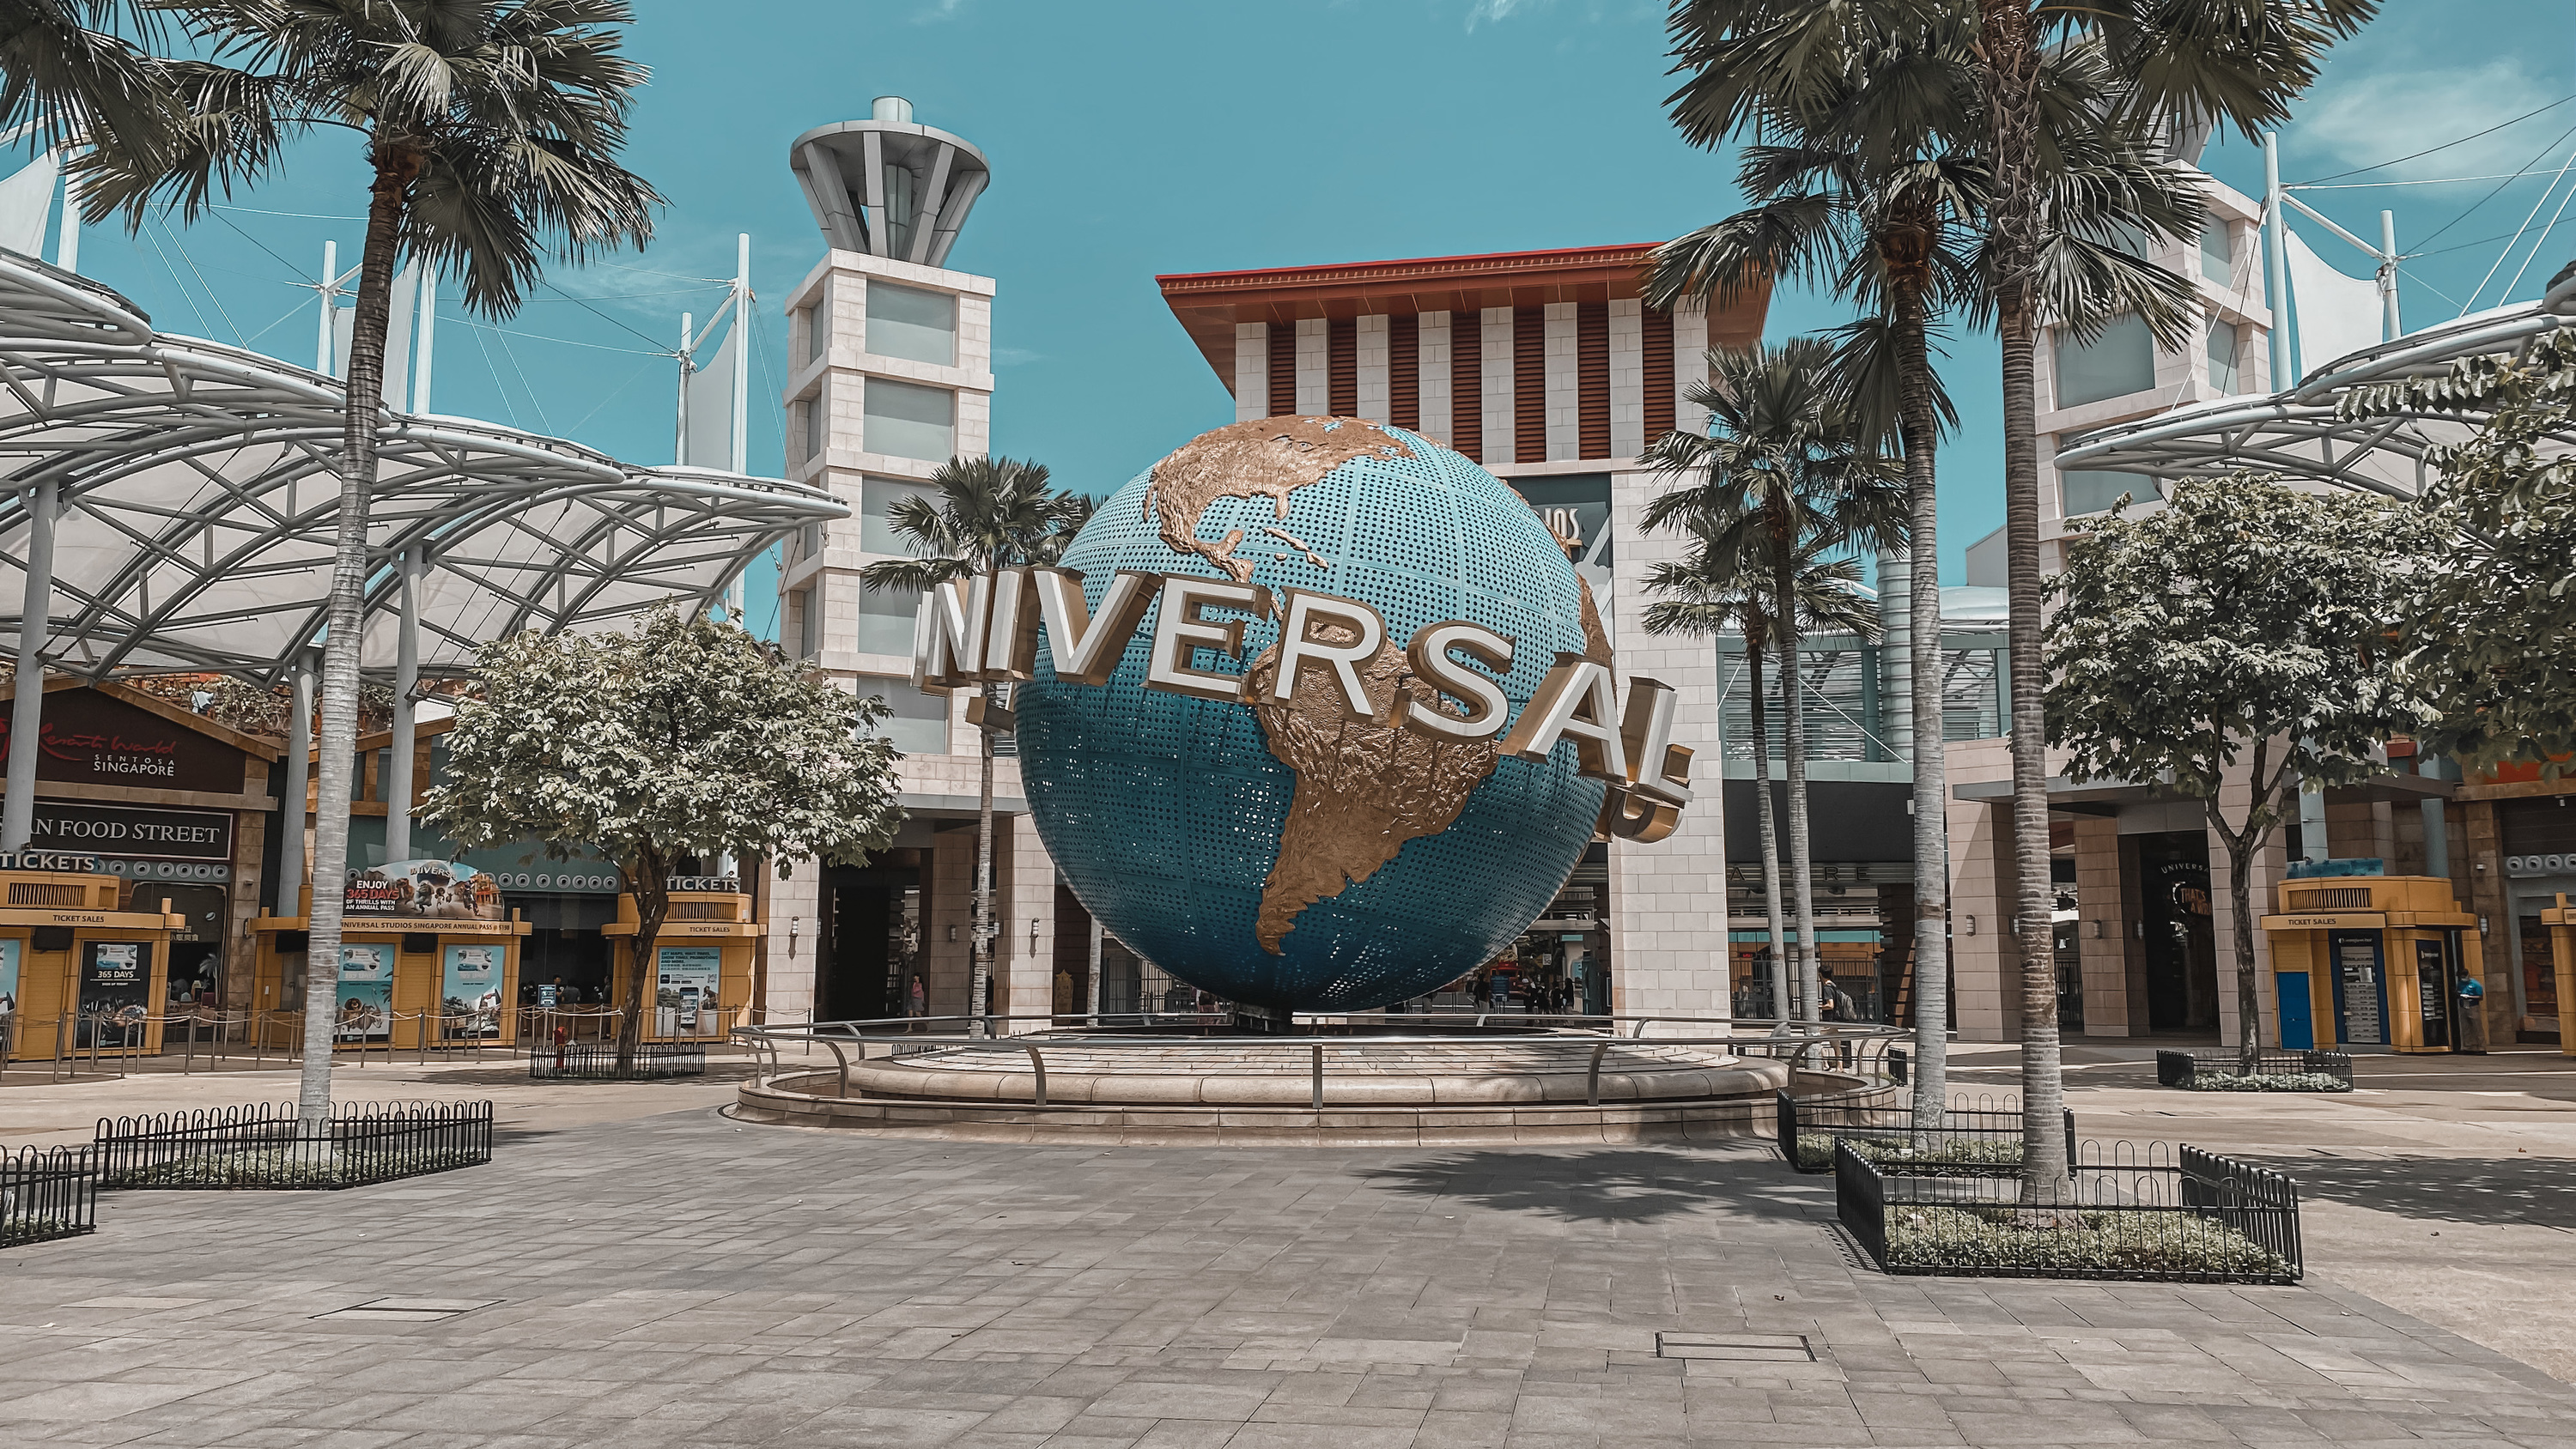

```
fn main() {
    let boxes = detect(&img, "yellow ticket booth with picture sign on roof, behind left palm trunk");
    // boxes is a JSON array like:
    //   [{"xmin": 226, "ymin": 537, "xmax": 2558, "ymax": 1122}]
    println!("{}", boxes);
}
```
[{"xmin": 250, "ymin": 859, "xmax": 528, "ymax": 1050}]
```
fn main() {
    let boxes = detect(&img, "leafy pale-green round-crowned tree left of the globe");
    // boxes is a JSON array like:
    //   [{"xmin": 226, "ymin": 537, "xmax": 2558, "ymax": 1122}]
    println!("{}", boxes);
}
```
[{"xmin": 420, "ymin": 608, "xmax": 904, "ymax": 1070}]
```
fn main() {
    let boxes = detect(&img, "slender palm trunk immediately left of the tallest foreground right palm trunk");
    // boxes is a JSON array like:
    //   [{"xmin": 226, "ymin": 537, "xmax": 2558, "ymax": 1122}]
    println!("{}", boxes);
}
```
[{"xmin": 1896, "ymin": 286, "xmax": 1950, "ymax": 1125}]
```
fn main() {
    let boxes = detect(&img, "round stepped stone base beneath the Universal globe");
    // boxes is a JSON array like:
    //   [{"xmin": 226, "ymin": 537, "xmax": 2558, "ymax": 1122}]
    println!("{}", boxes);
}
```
[{"xmin": 734, "ymin": 1032, "xmax": 1814, "ymax": 1148}]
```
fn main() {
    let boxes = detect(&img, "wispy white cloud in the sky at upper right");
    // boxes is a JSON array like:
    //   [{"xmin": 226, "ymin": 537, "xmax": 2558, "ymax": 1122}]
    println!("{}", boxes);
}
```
[{"xmin": 2282, "ymin": 59, "xmax": 2576, "ymax": 180}]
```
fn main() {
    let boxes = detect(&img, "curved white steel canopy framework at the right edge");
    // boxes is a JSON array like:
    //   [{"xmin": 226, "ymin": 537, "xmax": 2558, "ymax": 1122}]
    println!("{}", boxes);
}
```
[{"xmin": 2056, "ymin": 268, "xmax": 2576, "ymax": 500}]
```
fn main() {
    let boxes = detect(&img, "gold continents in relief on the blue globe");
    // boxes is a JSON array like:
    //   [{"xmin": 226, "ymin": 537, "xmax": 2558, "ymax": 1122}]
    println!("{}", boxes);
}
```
[{"xmin": 1146, "ymin": 417, "xmax": 1610, "ymax": 955}]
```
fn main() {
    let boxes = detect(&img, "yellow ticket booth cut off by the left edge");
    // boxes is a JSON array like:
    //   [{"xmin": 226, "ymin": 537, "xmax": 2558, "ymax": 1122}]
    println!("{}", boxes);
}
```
[{"xmin": 0, "ymin": 852, "xmax": 188, "ymax": 1060}]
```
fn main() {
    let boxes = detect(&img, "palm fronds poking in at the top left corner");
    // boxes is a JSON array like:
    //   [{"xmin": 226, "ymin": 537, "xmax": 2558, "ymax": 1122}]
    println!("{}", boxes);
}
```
[{"xmin": 0, "ymin": 0, "xmax": 175, "ymax": 144}]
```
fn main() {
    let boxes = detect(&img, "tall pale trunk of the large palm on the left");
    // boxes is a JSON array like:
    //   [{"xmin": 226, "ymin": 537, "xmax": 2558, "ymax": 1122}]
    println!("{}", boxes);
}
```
[{"xmin": 296, "ymin": 144, "xmax": 420, "ymax": 1132}]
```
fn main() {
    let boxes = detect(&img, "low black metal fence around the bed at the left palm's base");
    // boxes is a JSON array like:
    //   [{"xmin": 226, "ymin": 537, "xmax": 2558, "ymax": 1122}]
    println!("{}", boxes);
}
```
[{"xmin": 93, "ymin": 1101, "xmax": 492, "ymax": 1189}]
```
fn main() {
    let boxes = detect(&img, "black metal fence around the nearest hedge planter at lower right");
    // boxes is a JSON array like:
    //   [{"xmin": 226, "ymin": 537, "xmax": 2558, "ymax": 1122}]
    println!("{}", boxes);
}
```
[{"xmin": 1834, "ymin": 1140, "xmax": 2306, "ymax": 1284}]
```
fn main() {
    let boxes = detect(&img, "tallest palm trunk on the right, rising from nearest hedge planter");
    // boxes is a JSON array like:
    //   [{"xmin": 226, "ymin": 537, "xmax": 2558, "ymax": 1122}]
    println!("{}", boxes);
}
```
[{"xmin": 1978, "ymin": 0, "xmax": 2069, "ymax": 1202}]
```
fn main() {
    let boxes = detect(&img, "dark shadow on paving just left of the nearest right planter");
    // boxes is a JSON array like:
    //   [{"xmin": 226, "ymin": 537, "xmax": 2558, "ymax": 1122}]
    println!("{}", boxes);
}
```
[{"xmin": 1363, "ymin": 1145, "xmax": 1832, "ymax": 1222}]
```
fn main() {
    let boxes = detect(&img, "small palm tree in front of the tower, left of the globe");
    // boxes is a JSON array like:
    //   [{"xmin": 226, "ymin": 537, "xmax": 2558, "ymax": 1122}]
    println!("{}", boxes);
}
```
[{"xmin": 858, "ymin": 458, "xmax": 1092, "ymax": 1027}]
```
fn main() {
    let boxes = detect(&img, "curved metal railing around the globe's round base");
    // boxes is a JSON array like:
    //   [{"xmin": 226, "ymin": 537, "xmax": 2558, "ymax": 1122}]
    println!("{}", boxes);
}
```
[{"xmin": 734, "ymin": 1011, "xmax": 1911, "ymax": 1112}]
